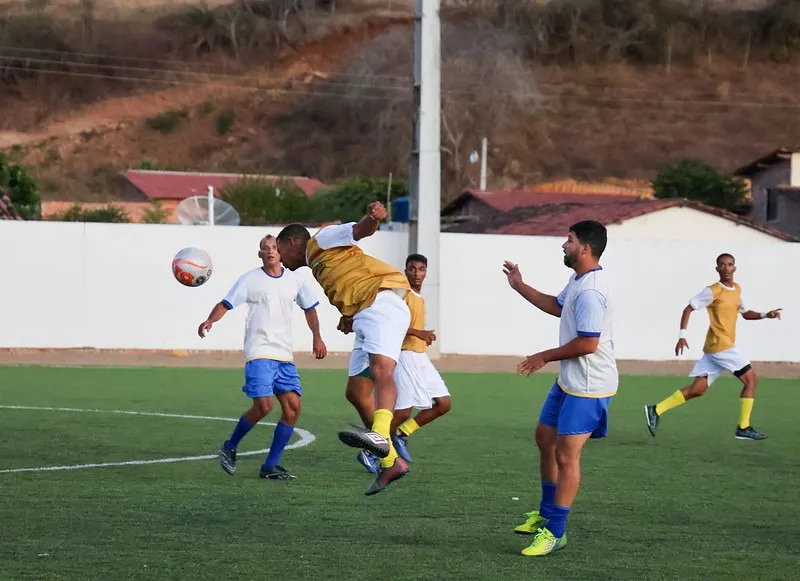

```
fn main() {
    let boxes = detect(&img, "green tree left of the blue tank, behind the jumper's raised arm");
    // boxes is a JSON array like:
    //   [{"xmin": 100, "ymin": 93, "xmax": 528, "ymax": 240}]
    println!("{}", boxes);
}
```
[{"xmin": 312, "ymin": 176, "xmax": 408, "ymax": 222}]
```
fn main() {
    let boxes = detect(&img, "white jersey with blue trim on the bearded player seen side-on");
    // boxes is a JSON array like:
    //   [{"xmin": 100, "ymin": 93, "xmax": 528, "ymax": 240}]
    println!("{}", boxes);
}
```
[{"xmin": 556, "ymin": 267, "xmax": 619, "ymax": 397}]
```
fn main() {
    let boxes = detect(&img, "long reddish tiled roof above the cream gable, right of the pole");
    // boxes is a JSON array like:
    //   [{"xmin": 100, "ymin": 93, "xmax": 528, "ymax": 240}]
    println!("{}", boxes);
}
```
[{"xmin": 448, "ymin": 194, "xmax": 800, "ymax": 242}]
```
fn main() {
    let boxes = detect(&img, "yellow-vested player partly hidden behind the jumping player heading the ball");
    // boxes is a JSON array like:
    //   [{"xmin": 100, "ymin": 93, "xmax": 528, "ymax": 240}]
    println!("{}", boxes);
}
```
[{"xmin": 346, "ymin": 254, "xmax": 451, "ymax": 472}]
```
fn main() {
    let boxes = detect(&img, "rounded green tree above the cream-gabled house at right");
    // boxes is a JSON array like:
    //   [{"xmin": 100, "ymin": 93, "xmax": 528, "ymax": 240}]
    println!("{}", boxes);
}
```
[{"xmin": 653, "ymin": 159, "xmax": 747, "ymax": 210}]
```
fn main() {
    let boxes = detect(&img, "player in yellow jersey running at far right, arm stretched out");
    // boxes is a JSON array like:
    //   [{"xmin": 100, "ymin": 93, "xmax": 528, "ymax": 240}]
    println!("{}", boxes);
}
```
[{"xmin": 644, "ymin": 254, "xmax": 781, "ymax": 440}]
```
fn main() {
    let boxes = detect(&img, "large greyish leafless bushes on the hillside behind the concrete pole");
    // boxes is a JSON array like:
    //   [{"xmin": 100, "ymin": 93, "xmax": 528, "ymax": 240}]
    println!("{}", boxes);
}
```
[{"xmin": 270, "ymin": 23, "xmax": 542, "ymax": 198}]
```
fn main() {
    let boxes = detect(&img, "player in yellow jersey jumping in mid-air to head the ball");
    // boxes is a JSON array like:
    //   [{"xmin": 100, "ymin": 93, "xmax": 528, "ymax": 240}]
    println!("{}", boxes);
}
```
[{"xmin": 278, "ymin": 202, "xmax": 411, "ymax": 495}]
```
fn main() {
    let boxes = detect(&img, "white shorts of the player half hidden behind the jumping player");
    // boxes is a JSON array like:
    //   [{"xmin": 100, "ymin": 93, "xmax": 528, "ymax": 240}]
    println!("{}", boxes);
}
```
[{"xmin": 394, "ymin": 351, "xmax": 450, "ymax": 410}]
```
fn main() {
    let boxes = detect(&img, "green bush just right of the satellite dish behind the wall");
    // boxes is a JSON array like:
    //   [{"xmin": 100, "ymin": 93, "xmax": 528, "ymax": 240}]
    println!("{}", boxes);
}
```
[{"xmin": 220, "ymin": 178, "xmax": 312, "ymax": 226}]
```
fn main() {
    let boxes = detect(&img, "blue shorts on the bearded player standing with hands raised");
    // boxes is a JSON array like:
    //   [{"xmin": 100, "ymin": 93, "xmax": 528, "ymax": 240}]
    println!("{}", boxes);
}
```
[{"xmin": 539, "ymin": 382, "xmax": 611, "ymax": 438}]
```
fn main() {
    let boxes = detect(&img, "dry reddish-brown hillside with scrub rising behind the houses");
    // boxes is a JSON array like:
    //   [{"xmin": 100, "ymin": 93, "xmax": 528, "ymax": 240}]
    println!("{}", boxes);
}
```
[{"xmin": 0, "ymin": 0, "xmax": 800, "ymax": 201}]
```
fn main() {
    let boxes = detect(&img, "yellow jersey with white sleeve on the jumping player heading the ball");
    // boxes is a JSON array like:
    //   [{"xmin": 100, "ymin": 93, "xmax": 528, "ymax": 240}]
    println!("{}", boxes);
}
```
[{"xmin": 306, "ymin": 222, "xmax": 411, "ymax": 317}]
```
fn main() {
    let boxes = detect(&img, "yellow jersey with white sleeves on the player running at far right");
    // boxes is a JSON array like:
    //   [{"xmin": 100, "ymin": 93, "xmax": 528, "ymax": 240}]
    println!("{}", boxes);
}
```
[{"xmin": 689, "ymin": 282, "xmax": 746, "ymax": 353}]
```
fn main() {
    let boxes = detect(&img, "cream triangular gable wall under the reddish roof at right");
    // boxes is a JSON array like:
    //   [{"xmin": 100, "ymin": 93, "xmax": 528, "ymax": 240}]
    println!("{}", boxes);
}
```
[{"xmin": 608, "ymin": 208, "xmax": 781, "ymax": 244}]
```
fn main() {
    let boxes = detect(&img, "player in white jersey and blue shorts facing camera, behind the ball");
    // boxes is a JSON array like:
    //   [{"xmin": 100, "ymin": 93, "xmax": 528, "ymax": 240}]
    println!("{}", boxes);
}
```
[{"xmin": 198, "ymin": 236, "xmax": 327, "ymax": 480}]
